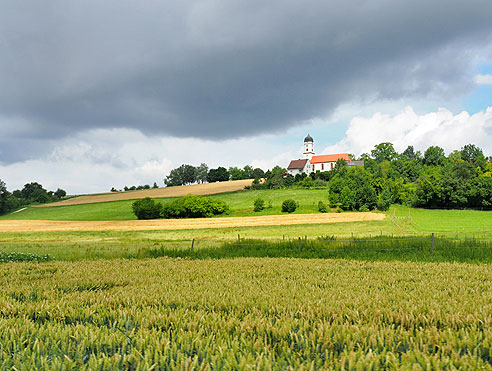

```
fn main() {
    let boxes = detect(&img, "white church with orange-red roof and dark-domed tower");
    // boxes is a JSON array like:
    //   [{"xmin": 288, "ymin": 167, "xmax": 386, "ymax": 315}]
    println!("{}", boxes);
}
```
[{"xmin": 287, "ymin": 134, "xmax": 364, "ymax": 176}]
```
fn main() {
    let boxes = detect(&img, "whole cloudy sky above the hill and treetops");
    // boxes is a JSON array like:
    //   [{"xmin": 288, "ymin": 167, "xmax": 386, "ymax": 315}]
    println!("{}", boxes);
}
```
[{"xmin": 0, "ymin": 0, "xmax": 492, "ymax": 194}]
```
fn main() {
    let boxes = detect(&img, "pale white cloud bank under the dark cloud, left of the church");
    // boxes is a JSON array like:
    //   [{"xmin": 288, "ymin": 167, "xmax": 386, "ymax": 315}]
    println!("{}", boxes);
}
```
[{"xmin": 0, "ymin": 129, "xmax": 298, "ymax": 194}]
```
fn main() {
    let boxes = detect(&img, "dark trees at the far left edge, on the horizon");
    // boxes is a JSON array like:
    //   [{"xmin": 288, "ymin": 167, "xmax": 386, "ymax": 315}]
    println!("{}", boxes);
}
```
[{"xmin": 0, "ymin": 179, "xmax": 67, "ymax": 214}]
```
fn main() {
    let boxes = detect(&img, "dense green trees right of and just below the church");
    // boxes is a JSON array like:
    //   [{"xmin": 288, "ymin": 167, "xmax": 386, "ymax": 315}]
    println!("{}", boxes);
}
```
[{"xmin": 253, "ymin": 142, "xmax": 492, "ymax": 210}]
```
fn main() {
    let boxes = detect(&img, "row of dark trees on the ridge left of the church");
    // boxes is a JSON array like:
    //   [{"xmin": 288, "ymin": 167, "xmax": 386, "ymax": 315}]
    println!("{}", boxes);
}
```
[{"xmin": 164, "ymin": 163, "xmax": 265, "ymax": 187}]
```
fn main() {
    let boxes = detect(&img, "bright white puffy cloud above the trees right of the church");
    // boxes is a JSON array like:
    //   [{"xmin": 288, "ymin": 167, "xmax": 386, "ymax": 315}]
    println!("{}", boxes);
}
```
[{"xmin": 323, "ymin": 107, "xmax": 492, "ymax": 155}]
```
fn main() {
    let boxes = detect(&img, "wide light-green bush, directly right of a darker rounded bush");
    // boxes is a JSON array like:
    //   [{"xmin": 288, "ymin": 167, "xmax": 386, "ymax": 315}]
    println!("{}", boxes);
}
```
[{"xmin": 161, "ymin": 195, "xmax": 229, "ymax": 219}]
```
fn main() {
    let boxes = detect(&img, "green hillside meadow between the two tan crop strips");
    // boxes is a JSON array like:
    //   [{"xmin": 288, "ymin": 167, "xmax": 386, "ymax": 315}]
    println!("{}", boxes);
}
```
[{"xmin": 0, "ymin": 189, "xmax": 328, "ymax": 221}]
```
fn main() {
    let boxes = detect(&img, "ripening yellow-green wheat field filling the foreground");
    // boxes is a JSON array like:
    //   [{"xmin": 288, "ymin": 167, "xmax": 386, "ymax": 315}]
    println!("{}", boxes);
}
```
[{"xmin": 0, "ymin": 258, "xmax": 492, "ymax": 370}]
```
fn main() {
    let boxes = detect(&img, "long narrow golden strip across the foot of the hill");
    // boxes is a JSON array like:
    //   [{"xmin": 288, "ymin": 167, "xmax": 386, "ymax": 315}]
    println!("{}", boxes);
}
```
[{"xmin": 0, "ymin": 212, "xmax": 385, "ymax": 233}]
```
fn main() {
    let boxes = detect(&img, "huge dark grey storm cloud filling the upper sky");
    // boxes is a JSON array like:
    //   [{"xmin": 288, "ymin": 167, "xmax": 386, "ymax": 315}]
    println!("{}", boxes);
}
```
[{"xmin": 0, "ymin": 0, "xmax": 492, "ymax": 162}]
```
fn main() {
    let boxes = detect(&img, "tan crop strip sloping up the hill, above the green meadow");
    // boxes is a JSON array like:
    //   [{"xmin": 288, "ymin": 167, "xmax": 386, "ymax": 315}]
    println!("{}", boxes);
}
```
[{"xmin": 35, "ymin": 179, "xmax": 253, "ymax": 207}]
